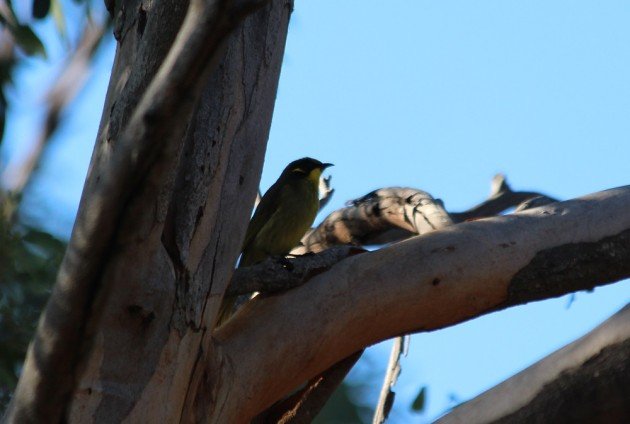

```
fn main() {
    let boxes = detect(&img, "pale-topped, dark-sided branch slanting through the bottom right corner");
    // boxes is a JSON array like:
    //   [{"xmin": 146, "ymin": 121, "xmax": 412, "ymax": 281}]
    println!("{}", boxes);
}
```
[{"xmin": 437, "ymin": 304, "xmax": 630, "ymax": 424}]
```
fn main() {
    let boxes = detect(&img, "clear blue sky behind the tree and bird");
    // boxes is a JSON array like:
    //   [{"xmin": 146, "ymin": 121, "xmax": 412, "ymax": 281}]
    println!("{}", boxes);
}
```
[{"xmin": 5, "ymin": 0, "xmax": 630, "ymax": 422}]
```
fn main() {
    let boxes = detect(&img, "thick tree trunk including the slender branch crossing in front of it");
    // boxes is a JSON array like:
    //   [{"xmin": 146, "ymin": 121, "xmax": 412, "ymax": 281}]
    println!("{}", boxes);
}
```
[{"xmin": 5, "ymin": 0, "xmax": 292, "ymax": 422}]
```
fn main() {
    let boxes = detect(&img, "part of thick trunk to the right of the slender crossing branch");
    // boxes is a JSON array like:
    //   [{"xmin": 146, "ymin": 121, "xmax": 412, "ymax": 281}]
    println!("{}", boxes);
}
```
[{"xmin": 71, "ymin": 0, "xmax": 292, "ymax": 422}]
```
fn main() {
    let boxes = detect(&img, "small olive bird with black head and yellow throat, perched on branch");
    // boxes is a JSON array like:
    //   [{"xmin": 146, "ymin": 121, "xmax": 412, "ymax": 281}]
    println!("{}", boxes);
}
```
[{"xmin": 217, "ymin": 158, "xmax": 332, "ymax": 326}]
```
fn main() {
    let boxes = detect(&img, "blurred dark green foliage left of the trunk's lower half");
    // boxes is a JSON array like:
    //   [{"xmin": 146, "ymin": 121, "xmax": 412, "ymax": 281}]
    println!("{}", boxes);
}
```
[{"xmin": 0, "ymin": 198, "xmax": 66, "ymax": 410}]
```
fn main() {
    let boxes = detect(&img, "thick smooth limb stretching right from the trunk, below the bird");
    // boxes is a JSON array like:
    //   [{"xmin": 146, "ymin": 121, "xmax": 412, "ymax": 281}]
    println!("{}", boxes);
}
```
[{"xmin": 211, "ymin": 187, "xmax": 630, "ymax": 422}]
